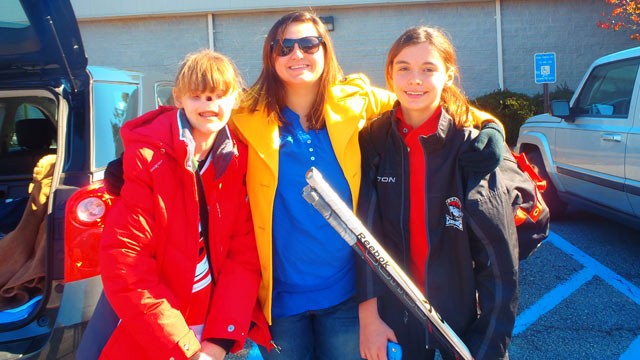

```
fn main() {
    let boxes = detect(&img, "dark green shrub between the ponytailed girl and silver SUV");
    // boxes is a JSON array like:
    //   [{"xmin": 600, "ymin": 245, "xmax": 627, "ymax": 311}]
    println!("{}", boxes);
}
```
[{"xmin": 471, "ymin": 90, "xmax": 542, "ymax": 146}]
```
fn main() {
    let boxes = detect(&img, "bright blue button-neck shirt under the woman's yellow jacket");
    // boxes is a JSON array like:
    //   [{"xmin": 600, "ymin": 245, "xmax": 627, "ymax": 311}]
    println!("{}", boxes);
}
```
[{"xmin": 272, "ymin": 108, "xmax": 355, "ymax": 318}]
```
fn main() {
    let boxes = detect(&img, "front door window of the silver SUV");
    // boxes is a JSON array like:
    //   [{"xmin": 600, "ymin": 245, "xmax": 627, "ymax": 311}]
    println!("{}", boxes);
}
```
[{"xmin": 572, "ymin": 58, "xmax": 640, "ymax": 117}]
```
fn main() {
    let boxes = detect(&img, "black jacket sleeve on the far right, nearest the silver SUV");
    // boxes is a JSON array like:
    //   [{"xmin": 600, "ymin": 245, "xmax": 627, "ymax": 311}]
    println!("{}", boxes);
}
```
[{"xmin": 464, "ymin": 145, "xmax": 519, "ymax": 359}]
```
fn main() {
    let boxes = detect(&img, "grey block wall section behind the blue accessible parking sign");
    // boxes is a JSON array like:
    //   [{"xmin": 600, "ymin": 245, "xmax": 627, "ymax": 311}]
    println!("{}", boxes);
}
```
[{"xmin": 502, "ymin": 0, "xmax": 640, "ymax": 94}]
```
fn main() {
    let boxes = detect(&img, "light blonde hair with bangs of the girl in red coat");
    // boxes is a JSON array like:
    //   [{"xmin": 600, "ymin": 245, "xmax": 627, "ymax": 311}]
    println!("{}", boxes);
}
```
[{"xmin": 175, "ymin": 49, "xmax": 243, "ymax": 96}]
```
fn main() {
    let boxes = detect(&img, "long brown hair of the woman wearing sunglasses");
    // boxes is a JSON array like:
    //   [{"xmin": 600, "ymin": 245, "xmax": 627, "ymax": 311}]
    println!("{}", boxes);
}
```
[{"xmin": 245, "ymin": 11, "xmax": 343, "ymax": 129}]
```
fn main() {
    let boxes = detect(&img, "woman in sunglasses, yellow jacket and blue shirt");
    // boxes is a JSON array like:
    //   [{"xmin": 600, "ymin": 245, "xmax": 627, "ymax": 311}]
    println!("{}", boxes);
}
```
[{"xmin": 232, "ymin": 12, "xmax": 503, "ymax": 360}]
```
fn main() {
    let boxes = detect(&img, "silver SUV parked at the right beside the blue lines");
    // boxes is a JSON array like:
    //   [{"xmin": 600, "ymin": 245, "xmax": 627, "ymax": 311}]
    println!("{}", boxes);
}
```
[{"xmin": 516, "ymin": 47, "xmax": 640, "ymax": 224}]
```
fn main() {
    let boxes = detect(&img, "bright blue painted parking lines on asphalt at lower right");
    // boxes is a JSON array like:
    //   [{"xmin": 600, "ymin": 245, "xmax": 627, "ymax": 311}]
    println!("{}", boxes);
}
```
[{"xmin": 513, "ymin": 232, "xmax": 640, "ymax": 360}]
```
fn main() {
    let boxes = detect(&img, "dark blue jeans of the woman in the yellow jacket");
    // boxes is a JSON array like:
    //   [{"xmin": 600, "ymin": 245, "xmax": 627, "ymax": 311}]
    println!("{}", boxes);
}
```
[{"xmin": 260, "ymin": 299, "xmax": 360, "ymax": 360}]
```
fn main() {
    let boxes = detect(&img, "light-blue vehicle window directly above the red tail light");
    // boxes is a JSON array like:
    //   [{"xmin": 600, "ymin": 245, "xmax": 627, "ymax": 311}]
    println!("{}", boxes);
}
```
[{"xmin": 93, "ymin": 83, "xmax": 140, "ymax": 168}]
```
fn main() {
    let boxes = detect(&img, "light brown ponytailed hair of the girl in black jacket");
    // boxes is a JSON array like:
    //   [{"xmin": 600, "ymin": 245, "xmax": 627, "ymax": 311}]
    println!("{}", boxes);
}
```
[{"xmin": 385, "ymin": 26, "xmax": 472, "ymax": 127}]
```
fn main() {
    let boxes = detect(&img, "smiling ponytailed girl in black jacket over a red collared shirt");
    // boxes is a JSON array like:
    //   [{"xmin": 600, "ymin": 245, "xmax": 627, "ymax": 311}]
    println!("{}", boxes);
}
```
[{"xmin": 358, "ymin": 27, "xmax": 523, "ymax": 360}]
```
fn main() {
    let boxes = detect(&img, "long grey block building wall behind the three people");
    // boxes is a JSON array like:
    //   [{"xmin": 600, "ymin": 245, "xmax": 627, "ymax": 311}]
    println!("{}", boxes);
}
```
[{"xmin": 75, "ymin": 0, "xmax": 640, "ymax": 109}]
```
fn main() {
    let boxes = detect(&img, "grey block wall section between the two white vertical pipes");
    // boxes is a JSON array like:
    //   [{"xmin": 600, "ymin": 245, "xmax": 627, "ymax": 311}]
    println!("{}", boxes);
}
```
[{"xmin": 214, "ymin": 3, "xmax": 498, "ymax": 98}]
